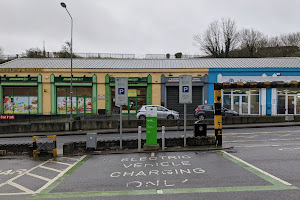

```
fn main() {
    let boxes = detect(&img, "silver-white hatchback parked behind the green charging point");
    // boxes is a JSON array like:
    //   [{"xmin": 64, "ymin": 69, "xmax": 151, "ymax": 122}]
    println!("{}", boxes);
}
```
[{"xmin": 136, "ymin": 105, "xmax": 179, "ymax": 119}]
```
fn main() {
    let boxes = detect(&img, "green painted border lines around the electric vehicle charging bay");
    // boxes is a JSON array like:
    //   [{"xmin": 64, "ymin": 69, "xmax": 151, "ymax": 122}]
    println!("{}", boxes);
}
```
[{"xmin": 29, "ymin": 151, "xmax": 298, "ymax": 199}]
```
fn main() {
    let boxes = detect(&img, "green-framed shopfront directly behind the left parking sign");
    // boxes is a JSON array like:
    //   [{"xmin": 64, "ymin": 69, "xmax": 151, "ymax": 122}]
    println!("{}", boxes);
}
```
[{"xmin": 105, "ymin": 74, "xmax": 152, "ymax": 115}]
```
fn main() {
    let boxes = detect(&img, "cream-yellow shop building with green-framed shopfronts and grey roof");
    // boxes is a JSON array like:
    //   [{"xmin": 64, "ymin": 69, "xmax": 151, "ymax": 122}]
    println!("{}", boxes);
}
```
[{"xmin": 0, "ymin": 58, "xmax": 208, "ymax": 115}]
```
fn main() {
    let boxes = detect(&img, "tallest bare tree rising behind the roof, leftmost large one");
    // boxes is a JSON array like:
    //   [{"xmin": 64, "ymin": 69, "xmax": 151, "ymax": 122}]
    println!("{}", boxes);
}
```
[{"xmin": 193, "ymin": 18, "xmax": 238, "ymax": 58}]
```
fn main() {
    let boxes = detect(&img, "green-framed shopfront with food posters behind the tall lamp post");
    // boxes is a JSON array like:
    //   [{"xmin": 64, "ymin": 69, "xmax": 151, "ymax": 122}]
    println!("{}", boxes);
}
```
[{"xmin": 51, "ymin": 74, "xmax": 97, "ymax": 115}]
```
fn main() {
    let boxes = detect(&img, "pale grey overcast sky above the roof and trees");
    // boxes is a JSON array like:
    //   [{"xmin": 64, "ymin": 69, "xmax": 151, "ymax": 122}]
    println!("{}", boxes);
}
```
[{"xmin": 0, "ymin": 0, "xmax": 300, "ymax": 55}]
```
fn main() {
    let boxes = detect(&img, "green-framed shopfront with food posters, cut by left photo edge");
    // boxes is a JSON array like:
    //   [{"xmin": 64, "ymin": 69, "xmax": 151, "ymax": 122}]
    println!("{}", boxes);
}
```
[{"xmin": 0, "ymin": 74, "xmax": 43, "ymax": 115}]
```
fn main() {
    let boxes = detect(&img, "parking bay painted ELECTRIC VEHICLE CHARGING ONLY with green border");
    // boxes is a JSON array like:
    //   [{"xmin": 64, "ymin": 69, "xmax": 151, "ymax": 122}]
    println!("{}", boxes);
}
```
[{"xmin": 31, "ymin": 151, "xmax": 298, "ymax": 198}]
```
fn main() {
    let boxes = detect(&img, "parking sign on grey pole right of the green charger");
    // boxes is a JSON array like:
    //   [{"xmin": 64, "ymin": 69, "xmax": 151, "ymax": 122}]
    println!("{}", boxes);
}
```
[{"xmin": 179, "ymin": 75, "xmax": 192, "ymax": 147}]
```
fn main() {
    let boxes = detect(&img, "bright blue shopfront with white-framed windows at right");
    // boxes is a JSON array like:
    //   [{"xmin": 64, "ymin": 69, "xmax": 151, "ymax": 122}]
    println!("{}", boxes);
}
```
[{"xmin": 208, "ymin": 68, "xmax": 300, "ymax": 116}]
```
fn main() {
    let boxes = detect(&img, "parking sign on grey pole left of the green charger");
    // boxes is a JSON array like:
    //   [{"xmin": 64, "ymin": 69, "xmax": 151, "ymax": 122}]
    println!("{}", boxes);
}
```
[{"xmin": 115, "ymin": 77, "xmax": 128, "ymax": 149}]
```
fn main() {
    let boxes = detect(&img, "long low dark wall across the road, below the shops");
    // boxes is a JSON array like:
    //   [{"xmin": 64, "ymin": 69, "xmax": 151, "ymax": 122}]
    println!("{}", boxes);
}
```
[{"xmin": 0, "ymin": 116, "xmax": 288, "ymax": 134}]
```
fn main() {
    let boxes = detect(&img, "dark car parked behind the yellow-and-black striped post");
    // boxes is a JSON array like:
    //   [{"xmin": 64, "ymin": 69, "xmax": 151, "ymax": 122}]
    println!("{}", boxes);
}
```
[{"xmin": 194, "ymin": 105, "xmax": 239, "ymax": 120}]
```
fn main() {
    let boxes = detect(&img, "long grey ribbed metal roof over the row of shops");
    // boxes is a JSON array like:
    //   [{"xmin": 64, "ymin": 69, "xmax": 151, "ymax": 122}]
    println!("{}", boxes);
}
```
[{"xmin": 0, "ymin": 57, "xmax": 300, "ymax": 69}]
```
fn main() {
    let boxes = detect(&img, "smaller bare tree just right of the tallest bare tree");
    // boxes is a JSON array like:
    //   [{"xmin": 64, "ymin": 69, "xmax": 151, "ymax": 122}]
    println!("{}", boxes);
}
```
[{"xmin": 240, "ymin": 28, "xmax": 268, "ymax": 57}]
